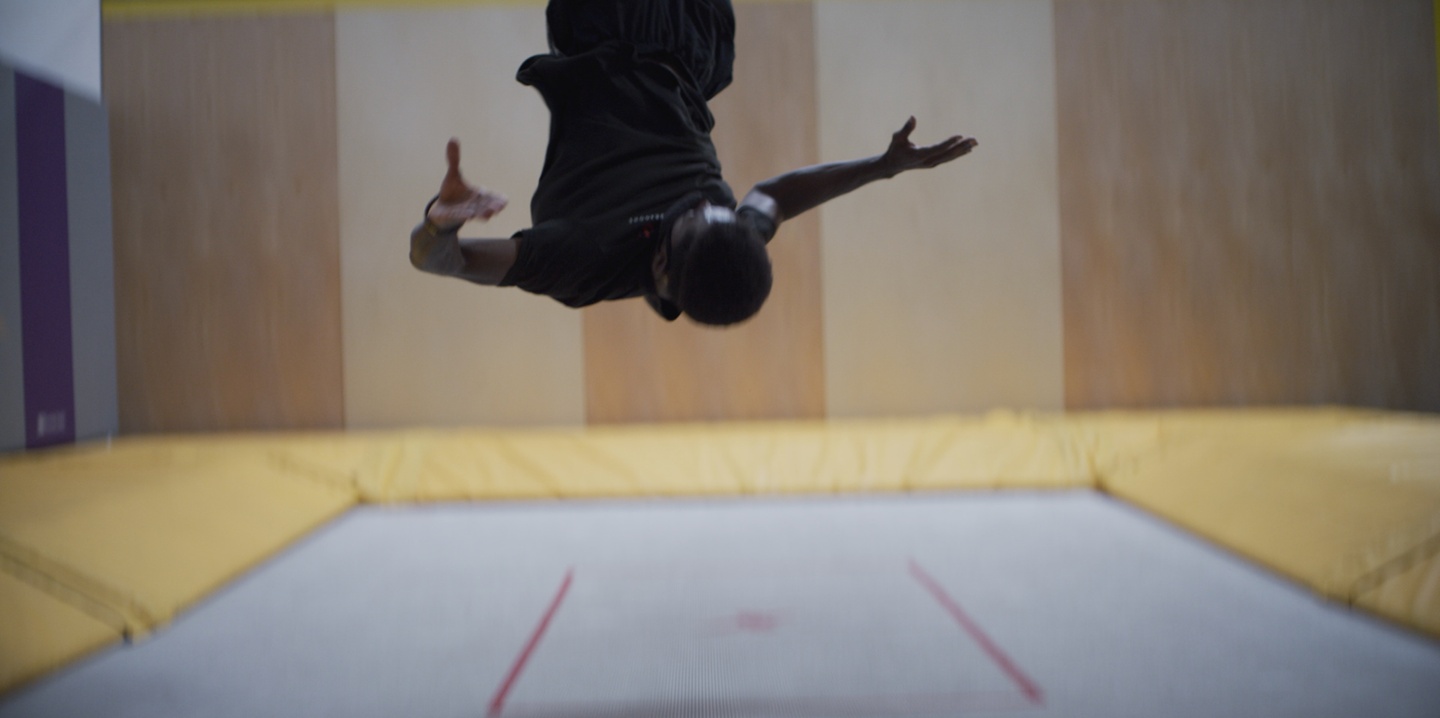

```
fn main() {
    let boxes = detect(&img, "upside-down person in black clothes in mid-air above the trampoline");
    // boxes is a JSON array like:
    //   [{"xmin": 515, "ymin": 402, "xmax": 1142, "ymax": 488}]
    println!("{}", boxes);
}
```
[{"xmin": 410, "ymin": 0, "xmax": 976, "ymax": 325}]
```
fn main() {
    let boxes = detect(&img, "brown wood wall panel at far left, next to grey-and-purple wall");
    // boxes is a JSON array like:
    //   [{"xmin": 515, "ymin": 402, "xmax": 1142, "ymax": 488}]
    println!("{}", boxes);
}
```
[{"xmin": 104, "ymin": 14, "xmax": 344, "ymax": 432}]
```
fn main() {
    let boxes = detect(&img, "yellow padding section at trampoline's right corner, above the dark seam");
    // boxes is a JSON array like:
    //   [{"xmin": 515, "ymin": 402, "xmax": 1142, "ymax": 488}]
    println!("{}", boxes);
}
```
[{"xmin": 1097, "ymin": 410, "xmax": 1440, "ymax": 641}]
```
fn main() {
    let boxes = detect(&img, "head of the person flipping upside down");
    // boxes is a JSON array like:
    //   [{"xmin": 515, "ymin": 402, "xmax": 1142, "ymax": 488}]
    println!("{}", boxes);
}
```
[{"xmin": 655, "ymin": 201, "xmax": 772, "ymax": 327}]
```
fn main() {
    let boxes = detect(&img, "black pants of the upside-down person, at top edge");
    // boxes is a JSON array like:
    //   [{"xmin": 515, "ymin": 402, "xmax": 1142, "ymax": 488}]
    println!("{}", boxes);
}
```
[{"xmin": 544, "ymin": 0, "xmax": 734, "ymax": 99}]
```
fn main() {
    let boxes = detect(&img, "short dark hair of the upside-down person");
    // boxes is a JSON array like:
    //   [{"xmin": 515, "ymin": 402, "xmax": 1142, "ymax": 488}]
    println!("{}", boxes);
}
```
[{"xmin": 675, "ymin": 222, "xmax": 773, "ymax": 327}]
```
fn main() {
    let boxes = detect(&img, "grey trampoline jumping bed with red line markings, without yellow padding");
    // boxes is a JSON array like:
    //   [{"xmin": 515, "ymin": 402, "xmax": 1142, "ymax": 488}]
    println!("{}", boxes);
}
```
[{"xmin": 0, "ymin": 491, "xmax": 1440, "ymax": 718}]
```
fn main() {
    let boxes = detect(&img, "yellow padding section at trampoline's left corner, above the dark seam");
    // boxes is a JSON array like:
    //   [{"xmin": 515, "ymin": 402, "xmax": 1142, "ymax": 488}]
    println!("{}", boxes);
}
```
[{"xmin": 0, "ymin": 439, "xmax": 356, "ymax": 635}]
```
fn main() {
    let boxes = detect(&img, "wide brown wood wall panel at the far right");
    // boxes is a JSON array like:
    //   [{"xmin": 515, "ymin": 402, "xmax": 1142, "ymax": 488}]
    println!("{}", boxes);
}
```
[{"xmin": 1056, "ymin": 0, "xmax": 1440, "ymax": 410}]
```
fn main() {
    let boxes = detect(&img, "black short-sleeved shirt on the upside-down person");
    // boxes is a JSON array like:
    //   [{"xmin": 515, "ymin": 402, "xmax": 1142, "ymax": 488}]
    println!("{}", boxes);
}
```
[{"xmin": 500, "ymin": 42, "xmax": 775, "ymax": 319}]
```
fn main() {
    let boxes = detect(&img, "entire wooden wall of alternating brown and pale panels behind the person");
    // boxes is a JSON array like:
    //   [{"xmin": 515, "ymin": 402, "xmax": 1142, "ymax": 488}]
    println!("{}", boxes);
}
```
[{"xmin": 104, "ymin": 0, "xmax": 1440, "ymax": 432}]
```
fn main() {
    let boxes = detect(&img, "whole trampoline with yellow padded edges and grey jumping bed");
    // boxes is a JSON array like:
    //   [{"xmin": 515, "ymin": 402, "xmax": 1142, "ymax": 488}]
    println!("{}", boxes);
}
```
[{"xmin": 0, "ymin": 410, "xmax": 1440, "ymax": 718}]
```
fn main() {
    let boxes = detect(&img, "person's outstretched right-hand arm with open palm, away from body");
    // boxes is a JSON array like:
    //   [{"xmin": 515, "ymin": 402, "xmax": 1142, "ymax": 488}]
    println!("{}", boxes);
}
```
[{"xmin": 743, "ymin": 117, "xmax": 979, "ymax": 223}]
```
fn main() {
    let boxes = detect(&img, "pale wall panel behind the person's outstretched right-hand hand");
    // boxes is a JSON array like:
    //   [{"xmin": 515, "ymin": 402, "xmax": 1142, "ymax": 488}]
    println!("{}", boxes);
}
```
[{"xmin": 815, "ymin": 0, "xmax": 1063, "ymax": 417}]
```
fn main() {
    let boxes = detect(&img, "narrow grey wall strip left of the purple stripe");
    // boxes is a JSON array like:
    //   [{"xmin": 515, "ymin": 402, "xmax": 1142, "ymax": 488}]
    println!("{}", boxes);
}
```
[{"xmin": 0, "ymin": 66, "xmax": 24, "ymax": 450}]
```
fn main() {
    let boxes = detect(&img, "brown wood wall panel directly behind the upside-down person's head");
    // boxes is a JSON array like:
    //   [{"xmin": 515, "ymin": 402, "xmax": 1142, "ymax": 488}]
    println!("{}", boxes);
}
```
[{"xmin": 583, "ymin": 3, "xmax": 825, "ymax": 423}]
